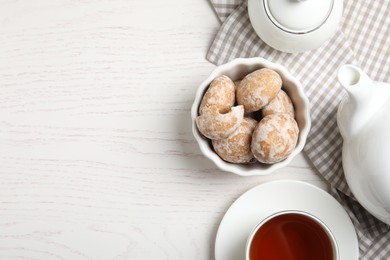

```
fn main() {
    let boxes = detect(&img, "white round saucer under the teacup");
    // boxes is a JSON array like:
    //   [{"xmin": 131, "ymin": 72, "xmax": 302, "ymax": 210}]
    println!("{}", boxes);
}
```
[{"xmin": 215, "ymin": 180, "xmax": 359, "ymax": 260}]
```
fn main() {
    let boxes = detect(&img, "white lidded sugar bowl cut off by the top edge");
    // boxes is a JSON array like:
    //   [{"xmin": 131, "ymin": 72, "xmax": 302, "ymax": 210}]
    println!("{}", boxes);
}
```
[{"xmin": 248, "ymin": 0, "xmax": 343, "ymax": 53}]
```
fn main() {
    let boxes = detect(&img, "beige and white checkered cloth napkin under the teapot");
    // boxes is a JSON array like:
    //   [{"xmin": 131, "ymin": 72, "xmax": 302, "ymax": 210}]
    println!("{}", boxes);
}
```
[{"xmin": 207, "ymin": 0, "xmax": 390, "ymax": 259}]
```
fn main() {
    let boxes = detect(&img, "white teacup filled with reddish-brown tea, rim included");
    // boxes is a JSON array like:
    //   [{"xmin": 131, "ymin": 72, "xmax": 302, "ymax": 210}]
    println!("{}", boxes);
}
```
[{"xmin": 246, "ymin": 210, "xmax": 339, "ymax": 260}]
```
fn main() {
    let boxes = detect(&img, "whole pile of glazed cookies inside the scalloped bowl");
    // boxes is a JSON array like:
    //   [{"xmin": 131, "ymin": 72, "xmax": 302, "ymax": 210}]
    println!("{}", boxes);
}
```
[{"xmin": 196, "ymin": 68, "xmax": 299, "ymax": 164}]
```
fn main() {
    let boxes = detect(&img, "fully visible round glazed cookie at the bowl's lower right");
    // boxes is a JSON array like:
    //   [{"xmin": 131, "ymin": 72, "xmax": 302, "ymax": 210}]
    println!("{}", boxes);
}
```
[{"xmin": 251, "ymin": 113, "xmax": 299, "ymax": 164}]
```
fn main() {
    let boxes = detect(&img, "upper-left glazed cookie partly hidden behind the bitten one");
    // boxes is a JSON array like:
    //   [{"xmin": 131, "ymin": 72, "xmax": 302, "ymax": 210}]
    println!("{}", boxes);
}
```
[{"xmin": 199, "ymin": 75, "xmax": 236, "ymax": 114}]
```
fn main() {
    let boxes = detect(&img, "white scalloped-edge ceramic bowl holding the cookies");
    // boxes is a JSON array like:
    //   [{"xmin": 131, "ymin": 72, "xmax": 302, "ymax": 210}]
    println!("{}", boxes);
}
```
[{"xmin": 191, "ymin": 58, "xmax": 311, "ymax": 176}]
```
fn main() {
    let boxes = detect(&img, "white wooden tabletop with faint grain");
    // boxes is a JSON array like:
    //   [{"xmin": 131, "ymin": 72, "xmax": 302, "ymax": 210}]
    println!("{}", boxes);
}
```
[{"xmin": 0, "ymin": 0, "xmax": 326, "ymax": 260}]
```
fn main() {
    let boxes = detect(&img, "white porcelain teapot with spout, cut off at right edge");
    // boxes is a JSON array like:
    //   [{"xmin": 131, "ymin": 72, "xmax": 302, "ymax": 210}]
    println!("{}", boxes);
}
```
[{"xmin": 337, "ymin": 65, "xmax": 390, "ymax": 224}]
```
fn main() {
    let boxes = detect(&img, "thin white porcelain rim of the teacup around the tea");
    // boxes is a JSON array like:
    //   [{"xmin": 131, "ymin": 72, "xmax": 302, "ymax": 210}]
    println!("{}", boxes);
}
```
[{"xmin": 245, "ymin": 210, "xmax": 340, "ymax": 260}]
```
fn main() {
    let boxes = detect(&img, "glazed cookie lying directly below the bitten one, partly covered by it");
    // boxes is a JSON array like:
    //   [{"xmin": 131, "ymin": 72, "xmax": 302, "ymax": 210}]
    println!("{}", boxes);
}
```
[{"xmin": 212, "ymin": 117, "xmax": 257, "ymax": 163}]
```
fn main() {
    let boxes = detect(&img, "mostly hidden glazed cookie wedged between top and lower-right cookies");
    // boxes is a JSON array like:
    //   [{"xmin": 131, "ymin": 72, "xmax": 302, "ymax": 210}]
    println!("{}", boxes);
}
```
[{"xmin": 262, "ymin": 89, "xmax": 295, "ymax": 118}]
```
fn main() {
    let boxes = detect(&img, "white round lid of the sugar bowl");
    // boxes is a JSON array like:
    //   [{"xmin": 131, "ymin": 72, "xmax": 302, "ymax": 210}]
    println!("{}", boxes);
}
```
[{"xmin": 264, "ymin": 0, "xmax": 334, "ymax": 33}]
